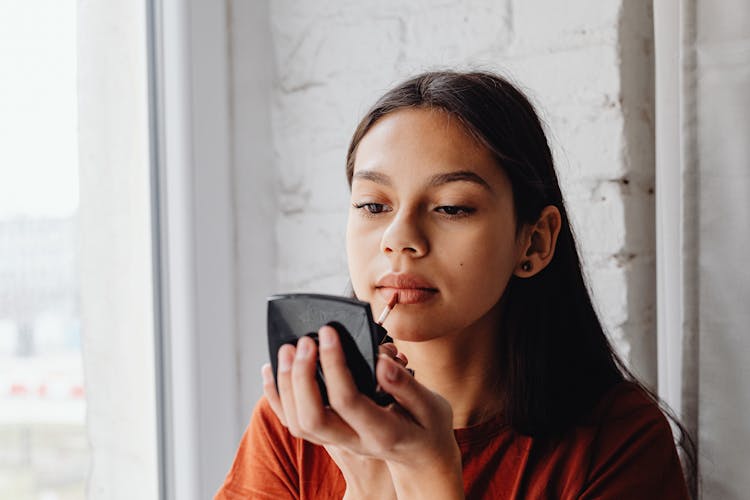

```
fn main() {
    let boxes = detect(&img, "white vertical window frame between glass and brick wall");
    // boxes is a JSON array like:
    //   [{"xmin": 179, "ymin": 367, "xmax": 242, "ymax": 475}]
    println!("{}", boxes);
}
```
[{"xmin": 147, "ymin": 0, "xmax": 241, "ymax": 500}]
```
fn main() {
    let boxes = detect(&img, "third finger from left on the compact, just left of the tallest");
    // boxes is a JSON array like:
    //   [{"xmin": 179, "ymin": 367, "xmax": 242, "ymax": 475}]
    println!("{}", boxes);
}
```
[{"xmin": 292, "ymin": 337, "xmax": 353, "ymax": 444}]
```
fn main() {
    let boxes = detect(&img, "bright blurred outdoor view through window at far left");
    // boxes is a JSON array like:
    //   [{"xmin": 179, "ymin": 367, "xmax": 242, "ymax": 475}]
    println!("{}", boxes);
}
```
[{"xmin": 0, "ymin": 0, "xmax": 90, "ymax": 500}]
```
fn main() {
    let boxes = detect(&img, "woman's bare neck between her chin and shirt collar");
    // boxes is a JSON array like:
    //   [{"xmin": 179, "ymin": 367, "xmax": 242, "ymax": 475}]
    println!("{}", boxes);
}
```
[{"xmin": 396, "ymin": 308, "xmax": 502, "ymax": 429}]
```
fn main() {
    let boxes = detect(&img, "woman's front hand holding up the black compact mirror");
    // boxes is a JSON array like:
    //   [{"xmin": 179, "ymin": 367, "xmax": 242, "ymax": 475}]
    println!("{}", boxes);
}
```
[{"xmin": 264, "ymin": 327, "xmax": 463, "ymax": 499}]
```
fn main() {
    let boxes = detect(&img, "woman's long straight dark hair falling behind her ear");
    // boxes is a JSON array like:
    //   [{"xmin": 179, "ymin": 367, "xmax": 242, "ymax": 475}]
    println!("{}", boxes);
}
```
[{"xmin": 346, "ymin": 71, "xmax": 695, "ymax": 482}]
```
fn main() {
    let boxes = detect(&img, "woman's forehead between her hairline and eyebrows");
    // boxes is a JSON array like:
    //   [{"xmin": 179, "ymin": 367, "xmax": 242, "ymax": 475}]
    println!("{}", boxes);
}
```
[{"xmin": 354, "ymin": 108, "xmax": 509, "ymax": 191}]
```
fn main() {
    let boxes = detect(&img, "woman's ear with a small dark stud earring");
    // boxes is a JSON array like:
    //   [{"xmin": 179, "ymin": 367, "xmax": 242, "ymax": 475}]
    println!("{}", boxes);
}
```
[{"xmin": 513, "ymin": 205, "xmax": 562, "ymax": 278}]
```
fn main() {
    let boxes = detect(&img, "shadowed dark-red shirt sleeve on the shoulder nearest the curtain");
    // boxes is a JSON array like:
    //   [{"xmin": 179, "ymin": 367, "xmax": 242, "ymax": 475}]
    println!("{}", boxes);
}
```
[{"xmin": 579, "ymin": 388, "xmax": 690, "ymax": 500}]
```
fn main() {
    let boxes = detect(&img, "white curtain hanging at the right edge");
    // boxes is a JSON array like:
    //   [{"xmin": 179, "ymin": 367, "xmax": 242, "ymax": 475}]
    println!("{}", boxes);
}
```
[{"xmin": 654, "ymin": 0, "xmax": 750, "ymax": 499}]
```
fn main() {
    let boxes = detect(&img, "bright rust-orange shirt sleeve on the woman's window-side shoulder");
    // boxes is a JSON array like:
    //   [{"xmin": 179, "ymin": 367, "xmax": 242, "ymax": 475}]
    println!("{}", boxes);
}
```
[{"xmin": 214, "ymin": 397, "xmax": 300, "ymax": 500}]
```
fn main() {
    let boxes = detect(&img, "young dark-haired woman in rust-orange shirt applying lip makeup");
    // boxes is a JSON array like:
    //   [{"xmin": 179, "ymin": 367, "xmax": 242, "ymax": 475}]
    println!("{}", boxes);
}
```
[{"xmin": 217, "ymin": 72, "xmax": 687, "ymax": 500}]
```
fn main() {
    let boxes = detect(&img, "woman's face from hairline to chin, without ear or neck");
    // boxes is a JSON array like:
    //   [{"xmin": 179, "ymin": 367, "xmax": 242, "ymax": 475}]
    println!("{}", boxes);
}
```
[{"xmin": 346, "ymin": 108, "xmax": 521, "ymax": 341}]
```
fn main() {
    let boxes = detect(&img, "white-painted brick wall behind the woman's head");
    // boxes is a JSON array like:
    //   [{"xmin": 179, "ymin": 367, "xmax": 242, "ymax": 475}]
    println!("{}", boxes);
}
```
[{"xmin": 234, "ymin": 0, "xmax": 655, "ymax": 388}]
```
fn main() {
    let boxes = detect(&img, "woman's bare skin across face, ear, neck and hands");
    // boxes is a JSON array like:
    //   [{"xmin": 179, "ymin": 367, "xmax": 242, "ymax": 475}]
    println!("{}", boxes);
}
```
[{"xmin": 263, "ymin": 108, "xmax": 560, "ymax": 499}]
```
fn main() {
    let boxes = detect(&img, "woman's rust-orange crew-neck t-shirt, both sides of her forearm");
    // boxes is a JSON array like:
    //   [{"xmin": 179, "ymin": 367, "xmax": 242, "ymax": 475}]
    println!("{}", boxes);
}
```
[{"xmin": 215, "ymin": 382, "xmax": 689, "ymax": 499}]
